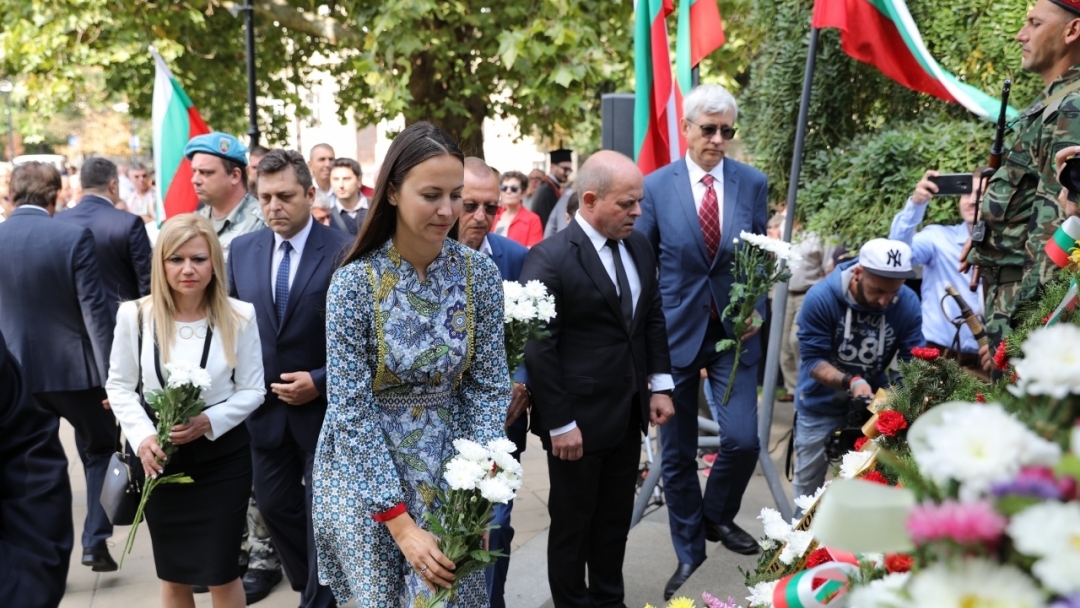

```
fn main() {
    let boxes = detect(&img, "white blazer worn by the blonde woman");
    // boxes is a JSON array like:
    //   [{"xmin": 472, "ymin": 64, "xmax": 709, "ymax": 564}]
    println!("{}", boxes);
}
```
[{"xmin": 105, "ymin": 298, "xmax": 266, "ymax": 449}]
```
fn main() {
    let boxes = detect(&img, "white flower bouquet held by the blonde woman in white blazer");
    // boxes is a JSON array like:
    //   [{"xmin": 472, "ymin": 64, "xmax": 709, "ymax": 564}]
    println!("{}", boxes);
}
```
[{"xmin": 120, "ymin": 361, "xmax": 211, "ymax": 566}]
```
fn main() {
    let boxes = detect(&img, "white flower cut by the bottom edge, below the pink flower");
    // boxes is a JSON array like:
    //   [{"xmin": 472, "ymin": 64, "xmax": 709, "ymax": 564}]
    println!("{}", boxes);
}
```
[{"xmin": 907, "ymin": 559, "xmax": 1045, "ymax": 608}]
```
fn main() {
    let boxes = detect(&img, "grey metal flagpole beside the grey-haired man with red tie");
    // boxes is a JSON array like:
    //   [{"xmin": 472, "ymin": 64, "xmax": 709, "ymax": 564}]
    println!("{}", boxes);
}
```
[{"xmin": 757, "ymin": 28, "xmax": 819, "ymax": 521}]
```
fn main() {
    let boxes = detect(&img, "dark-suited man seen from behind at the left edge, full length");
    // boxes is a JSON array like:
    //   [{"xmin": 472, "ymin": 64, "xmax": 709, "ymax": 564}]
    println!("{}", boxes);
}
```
[{"xmin": 0, "ymin": 163, "xmax": 117, "ymax": 572}]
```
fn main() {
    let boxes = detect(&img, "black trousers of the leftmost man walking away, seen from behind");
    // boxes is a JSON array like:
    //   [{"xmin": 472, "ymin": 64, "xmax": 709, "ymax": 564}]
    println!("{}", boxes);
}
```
[{"xmin": 33, "ymin": 387, "xmax": 117, "ymax": 549}]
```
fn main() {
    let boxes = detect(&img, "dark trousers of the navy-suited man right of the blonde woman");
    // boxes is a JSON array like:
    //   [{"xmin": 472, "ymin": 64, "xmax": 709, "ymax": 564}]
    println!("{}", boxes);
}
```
[{"xmin": 252, "ymin": 429, "xmax": 337, "ymax": 608}]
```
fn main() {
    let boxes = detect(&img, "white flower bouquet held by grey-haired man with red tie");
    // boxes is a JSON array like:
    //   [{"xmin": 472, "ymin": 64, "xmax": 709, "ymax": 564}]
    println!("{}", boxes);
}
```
[{"xmin": 716, "ymin": 230, "xmax": 801, "ymax": 405}]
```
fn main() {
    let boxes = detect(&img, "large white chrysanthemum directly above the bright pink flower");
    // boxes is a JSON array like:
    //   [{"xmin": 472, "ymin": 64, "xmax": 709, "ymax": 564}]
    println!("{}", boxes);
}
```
[{"xmin": 908, "ymin": 403, "xmax": 1062, "ymax": 501}]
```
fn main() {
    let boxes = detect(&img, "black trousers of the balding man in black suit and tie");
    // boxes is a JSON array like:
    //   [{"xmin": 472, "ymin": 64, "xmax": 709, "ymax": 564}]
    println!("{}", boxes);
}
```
[{"xmin": 548, "ymin": 408, "xmax": 642, "ymax": 608}]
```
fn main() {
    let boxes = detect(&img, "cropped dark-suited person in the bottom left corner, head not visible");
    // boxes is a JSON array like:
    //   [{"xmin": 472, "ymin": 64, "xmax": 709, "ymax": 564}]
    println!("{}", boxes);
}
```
[{"xmin": 0, "ymin": 334, "xmax": 75, "ymax": 608}]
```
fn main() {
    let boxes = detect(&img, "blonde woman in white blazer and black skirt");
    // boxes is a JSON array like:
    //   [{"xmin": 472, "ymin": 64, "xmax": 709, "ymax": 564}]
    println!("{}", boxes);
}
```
[{"xmin": 105, "ymin": 214, "xmax": 266, "ymax": 608}]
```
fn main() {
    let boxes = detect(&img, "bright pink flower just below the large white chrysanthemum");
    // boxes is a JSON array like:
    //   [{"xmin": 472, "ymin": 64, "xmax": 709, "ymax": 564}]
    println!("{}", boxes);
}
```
[{"xmin": 907, "ymin": 500, "xmax": 1009, "ymax": 545}]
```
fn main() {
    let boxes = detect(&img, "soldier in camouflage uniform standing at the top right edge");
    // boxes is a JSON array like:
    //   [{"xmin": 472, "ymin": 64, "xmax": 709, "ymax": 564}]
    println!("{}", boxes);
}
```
[{"xmin": 967, "ymin": 0, "xmax": 1080, "ymax": 370}]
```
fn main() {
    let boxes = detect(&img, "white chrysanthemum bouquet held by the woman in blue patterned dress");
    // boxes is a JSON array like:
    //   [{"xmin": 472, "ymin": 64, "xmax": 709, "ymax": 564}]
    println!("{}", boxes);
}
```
[{"xmin": 424, "ymin": 437, "xmax": 522, "ymax": 608}]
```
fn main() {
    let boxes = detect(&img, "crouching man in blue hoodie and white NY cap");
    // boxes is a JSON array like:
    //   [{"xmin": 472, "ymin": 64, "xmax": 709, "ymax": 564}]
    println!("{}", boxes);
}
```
[{"xmin": 793, "ymin": 239, "xmax": 923, "ymax": 496}]
